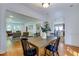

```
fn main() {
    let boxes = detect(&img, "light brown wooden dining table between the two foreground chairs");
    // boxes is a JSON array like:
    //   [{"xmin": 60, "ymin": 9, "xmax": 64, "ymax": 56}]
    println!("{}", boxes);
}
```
[{"xmin": 28, "ymin": 37, "xmax": 56, "ymax": 56}]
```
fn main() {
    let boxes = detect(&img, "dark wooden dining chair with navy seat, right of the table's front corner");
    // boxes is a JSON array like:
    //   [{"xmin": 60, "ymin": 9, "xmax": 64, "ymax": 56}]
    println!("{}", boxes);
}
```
[{"xmin": 45, "ymin": 37, "xmax": 60, "ymax": 56}]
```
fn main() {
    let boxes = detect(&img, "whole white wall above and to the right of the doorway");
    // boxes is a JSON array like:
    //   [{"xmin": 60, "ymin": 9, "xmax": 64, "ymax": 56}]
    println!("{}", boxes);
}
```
[{"xmin": 48, "ymin": 4, "xmax": 79, "ymax": 47}]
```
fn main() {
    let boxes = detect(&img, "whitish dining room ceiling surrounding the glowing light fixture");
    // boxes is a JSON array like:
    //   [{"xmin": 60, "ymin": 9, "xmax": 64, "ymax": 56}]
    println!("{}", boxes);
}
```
[{"xmin": 22, "ymin": 3, "xmax": 79, "ymax": 14}]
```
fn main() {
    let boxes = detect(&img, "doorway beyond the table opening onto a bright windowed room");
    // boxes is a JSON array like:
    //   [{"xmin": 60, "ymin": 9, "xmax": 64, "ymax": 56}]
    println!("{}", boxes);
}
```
[{"xmin": 54, "ymin": 24, "xmax": 65, "ymax": 43}]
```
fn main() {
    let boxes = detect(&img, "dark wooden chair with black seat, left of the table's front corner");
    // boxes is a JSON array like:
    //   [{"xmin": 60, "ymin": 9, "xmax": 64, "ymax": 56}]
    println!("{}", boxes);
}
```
[{"xmin": 21, "ymin": 38, "xmax": 36, "ymax": 56}]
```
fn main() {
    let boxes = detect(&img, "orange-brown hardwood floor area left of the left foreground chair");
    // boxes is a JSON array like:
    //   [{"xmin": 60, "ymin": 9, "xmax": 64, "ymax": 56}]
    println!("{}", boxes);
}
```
[{"xmin": 0, "ymin": 40, "xmax": 23, "ymax": 56}]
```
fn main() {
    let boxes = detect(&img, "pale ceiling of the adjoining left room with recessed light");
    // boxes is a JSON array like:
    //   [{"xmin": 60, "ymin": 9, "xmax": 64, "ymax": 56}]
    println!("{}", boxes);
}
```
[{"xmin": 6, "ymin": 10, "xmax": 38, "ymax": 23}]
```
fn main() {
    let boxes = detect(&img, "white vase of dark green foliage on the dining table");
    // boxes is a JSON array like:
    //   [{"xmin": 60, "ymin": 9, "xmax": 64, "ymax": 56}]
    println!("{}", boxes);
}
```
[{"xmin": 41, "ymin": 21, "xmax": 51, "ymax": 39}]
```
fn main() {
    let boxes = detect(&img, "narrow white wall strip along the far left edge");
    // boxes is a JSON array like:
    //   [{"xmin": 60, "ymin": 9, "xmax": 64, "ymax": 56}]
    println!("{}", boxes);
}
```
[{"xmin": 0, "ymin": 4, "xmax": 7, "ymax": 54}]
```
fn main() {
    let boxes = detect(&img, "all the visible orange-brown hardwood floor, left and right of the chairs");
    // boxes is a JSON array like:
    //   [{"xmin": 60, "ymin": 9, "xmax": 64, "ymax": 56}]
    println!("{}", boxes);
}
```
[{"xmin": 0, "ymin": 37, "xmax": 79, "ymax": 56}]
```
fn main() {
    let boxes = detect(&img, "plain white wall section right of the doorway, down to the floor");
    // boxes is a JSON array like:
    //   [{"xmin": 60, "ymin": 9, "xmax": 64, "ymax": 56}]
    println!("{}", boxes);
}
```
[{"xmin": 65, "ymin": 6, "xmax": 79, "ymax": 47}]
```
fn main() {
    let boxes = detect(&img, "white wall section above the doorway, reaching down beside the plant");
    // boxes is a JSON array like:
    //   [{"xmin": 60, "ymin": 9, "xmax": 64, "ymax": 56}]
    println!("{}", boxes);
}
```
[{"xmin": 47, "ymin": 10, "xmax": 64, "ymax": 33}]
